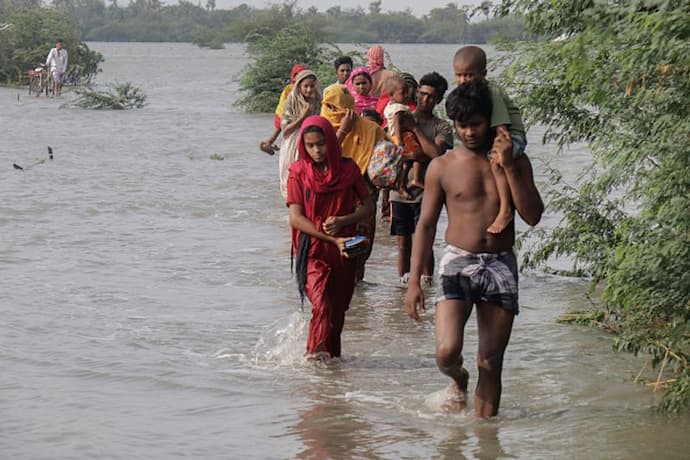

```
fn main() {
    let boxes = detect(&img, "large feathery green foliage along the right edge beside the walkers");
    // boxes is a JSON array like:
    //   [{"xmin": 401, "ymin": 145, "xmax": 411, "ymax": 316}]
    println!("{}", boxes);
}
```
[{"xmin": 503, "ymin": 0, "xmax": 690, "ymax": 412}]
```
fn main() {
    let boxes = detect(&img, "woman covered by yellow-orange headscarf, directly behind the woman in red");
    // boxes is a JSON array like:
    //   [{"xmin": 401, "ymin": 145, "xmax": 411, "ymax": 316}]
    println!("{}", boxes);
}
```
[{"xmin": 321, "ymin": 85, "xmax": 386, "ymax": 281}]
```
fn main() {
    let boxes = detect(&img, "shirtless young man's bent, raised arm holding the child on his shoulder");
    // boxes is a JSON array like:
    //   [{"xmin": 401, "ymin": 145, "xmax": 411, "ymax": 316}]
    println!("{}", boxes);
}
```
[{"xmin": 494, "ymin": 128, "xmax": 544, "ymax": 225}]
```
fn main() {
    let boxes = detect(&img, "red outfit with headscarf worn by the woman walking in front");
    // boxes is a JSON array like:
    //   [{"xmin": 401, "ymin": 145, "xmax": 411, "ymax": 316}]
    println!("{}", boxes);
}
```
[{"xmin": 287, "ymin": 116, "xmax": 369, "ymax": 357}]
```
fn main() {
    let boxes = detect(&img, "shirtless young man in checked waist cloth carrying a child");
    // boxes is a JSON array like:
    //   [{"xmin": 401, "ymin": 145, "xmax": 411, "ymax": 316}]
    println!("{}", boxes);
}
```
[{"xmin": 405, "ymin": 80, "xmax": 544, "ymax": 417}]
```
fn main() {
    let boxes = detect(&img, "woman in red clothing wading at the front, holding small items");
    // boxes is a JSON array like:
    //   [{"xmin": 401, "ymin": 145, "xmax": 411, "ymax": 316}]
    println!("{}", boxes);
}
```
[{"xmin": 287, "ymin": 115, "xmax": 375, "ymax": 357}]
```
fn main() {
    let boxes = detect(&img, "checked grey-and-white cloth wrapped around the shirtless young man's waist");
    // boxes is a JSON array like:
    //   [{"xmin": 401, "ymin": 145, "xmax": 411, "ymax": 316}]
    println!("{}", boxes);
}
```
[{"xmin": 436, "ymin": 244, "xmax": 519, "ymax": 315}]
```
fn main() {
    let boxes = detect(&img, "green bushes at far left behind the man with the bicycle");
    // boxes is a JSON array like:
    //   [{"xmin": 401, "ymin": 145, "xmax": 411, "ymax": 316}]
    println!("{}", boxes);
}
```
[{"xmin": 0, "ymin": 0, "xmax": 103, "ymax": 83}]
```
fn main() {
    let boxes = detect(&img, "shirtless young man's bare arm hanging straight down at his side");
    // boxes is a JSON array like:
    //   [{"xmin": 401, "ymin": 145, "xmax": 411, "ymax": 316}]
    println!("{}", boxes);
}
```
[{"xmin": 405, "ymin": 160, "xmax": 445, "ymax": 320}]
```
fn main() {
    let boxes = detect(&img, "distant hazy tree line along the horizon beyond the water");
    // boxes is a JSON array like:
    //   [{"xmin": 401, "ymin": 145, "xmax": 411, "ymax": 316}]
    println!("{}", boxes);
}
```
[{"xmin": 52, "ymin": 0, "xmax": 526, "ymax": 47}]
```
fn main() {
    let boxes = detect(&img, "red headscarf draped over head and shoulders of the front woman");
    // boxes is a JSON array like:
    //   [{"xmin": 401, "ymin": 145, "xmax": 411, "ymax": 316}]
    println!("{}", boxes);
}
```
[{"xmin": 290, "ymin": 115, "xmax": 362, "ymax": 193}]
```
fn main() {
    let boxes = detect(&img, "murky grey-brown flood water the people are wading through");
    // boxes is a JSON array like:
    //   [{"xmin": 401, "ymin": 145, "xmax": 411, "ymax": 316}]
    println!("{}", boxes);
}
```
[{"xmin": 0, "ymin": 43, "xmax": 690, "ymax": 459}]
